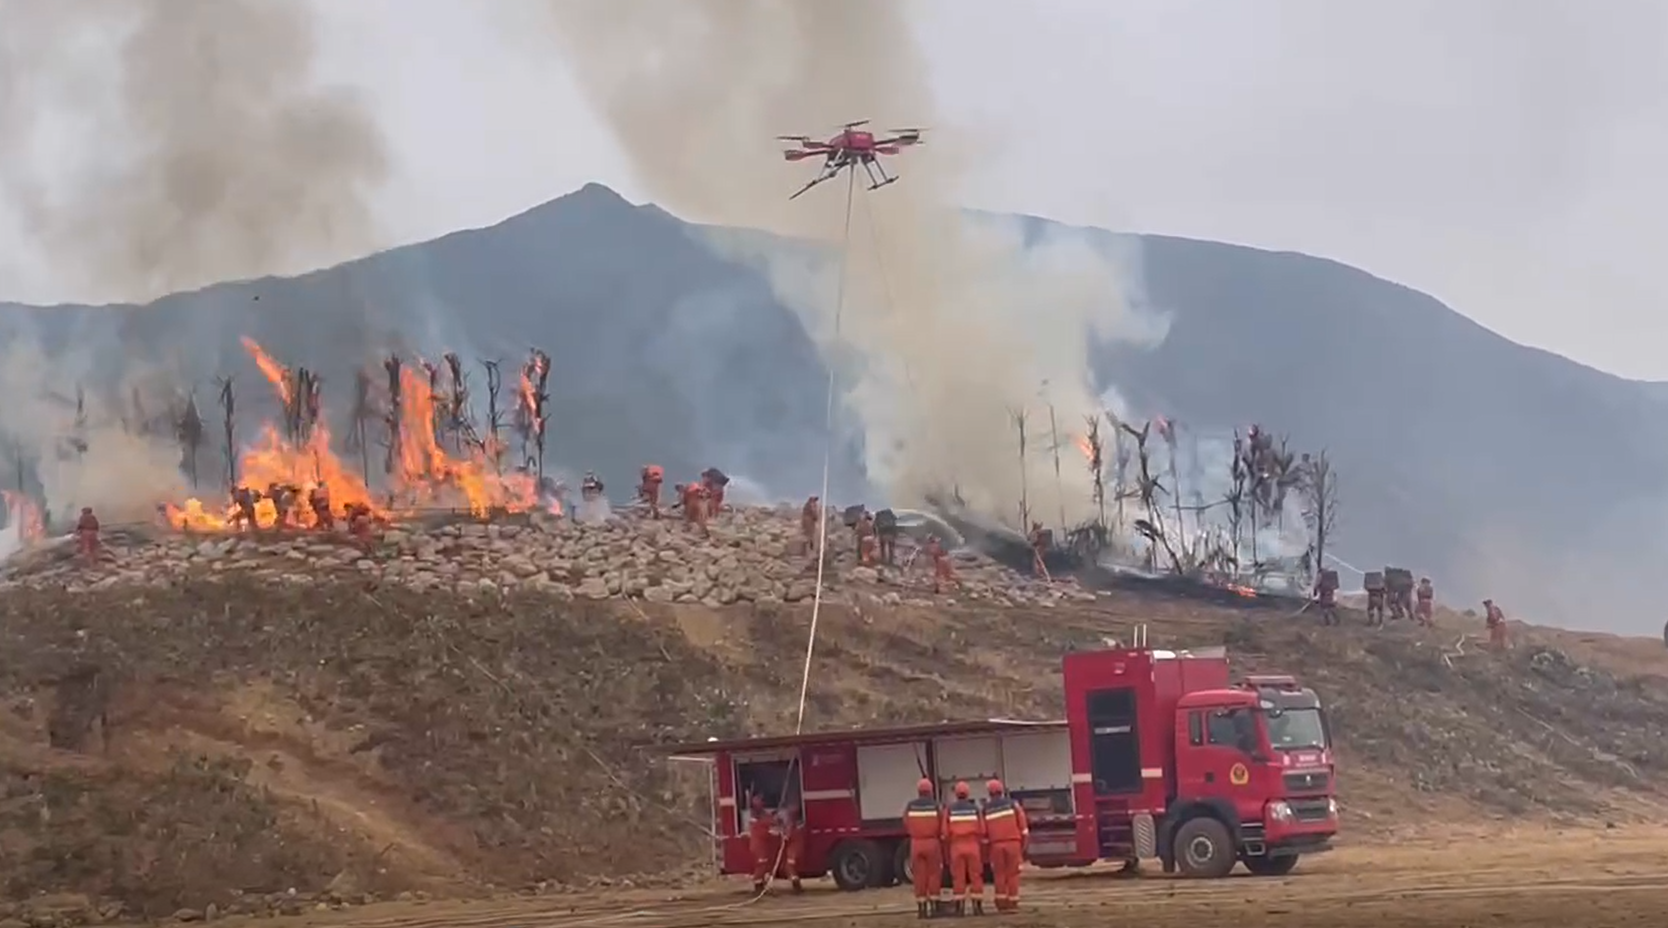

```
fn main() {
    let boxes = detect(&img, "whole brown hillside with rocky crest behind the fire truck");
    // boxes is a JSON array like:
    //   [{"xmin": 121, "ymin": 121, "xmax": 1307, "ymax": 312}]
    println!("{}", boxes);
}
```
[{"xmin": 0, "ymin": 511, "xmax": 1668, "ymax": 923}]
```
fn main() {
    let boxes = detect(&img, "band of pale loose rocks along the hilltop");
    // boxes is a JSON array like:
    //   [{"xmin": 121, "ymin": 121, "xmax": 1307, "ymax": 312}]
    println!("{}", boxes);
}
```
[{"xmin": 0, "ymin": 507, "xmax": 1094, "ymax": 606}]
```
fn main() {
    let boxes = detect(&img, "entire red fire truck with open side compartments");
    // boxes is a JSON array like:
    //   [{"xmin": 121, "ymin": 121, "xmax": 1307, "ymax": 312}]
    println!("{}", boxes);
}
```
[{"xmin": 671, "ymin": 648, "xmax": 1338, "ymax": 890}]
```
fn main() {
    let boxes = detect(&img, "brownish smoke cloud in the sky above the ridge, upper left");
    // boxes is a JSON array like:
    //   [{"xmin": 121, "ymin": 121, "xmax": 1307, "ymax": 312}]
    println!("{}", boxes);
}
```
[{"xmin": 0, "ymin": 0, "xmax": 389, "ymax": 302}]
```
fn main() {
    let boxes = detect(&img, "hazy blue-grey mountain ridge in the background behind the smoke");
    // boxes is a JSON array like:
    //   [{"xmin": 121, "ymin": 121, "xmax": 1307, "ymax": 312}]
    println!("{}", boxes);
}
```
[{"xmin": 0, "ymin": 184, "xmax": 1668, "ymax": 628}]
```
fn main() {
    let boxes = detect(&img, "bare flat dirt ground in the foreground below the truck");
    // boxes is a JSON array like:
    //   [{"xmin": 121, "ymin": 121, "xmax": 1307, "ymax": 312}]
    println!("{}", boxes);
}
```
[{"xmin": 231, "ymin": 826, "xmax": 1668, "ymax": 928}]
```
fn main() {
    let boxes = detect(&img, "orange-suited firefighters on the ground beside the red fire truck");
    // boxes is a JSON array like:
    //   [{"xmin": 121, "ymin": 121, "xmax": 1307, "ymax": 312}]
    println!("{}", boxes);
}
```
[{"xmin": 747, "ymin": 778, "xmax": 1031, "ymax": 918}]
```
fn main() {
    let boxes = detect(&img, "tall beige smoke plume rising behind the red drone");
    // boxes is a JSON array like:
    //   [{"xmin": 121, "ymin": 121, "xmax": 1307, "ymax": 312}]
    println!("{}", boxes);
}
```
[{"xmin": 522, "ymin": 0, "xmax": 1154, "ymax": 521}]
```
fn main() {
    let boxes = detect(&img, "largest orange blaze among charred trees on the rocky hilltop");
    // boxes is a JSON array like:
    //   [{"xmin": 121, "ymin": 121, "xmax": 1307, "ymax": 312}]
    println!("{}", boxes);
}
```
[{"xmin": 163, "ymin": 337, "xmax": 537, "ymax": 531}]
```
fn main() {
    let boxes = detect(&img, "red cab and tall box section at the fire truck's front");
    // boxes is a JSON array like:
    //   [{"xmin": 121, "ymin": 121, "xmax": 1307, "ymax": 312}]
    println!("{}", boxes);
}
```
[{"xmin": 1074, "ymin": 648, "xmax": 1338, "ymax": 876}]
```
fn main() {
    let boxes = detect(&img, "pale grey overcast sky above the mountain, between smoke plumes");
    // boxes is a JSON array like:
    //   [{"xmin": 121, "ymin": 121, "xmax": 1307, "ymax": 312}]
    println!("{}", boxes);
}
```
[{"xmin": 0, "ymin": 0, "xmax": 1668, "ymax": 379}]
